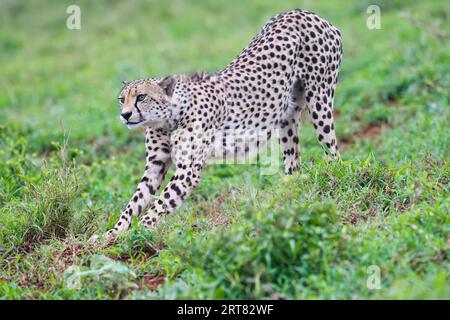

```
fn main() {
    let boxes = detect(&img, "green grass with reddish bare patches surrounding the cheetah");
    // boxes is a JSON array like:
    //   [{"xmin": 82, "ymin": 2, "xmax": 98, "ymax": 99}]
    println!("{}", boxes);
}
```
[{"xmin": 0, "ymin": 0, "xmax": 450, "ymax": 299}]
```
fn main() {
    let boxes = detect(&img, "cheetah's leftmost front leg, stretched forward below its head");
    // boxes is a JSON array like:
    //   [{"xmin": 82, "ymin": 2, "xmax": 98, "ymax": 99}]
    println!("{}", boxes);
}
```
[{"xmin": 107, "ymin": 128, "xmax": 171, "ymax": 236}]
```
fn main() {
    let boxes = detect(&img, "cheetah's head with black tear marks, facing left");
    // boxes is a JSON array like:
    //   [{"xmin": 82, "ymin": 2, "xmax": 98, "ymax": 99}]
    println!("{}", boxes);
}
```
[{"xmin": 119, "ymin": 76, "xmax": 176, "ymax": 129}]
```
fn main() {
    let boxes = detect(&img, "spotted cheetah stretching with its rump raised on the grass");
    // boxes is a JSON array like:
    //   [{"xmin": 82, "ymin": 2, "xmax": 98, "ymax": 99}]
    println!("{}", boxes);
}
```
[{"xmin": 107, "ymin": 9, "xmax": 342, "ymax": 236}]
